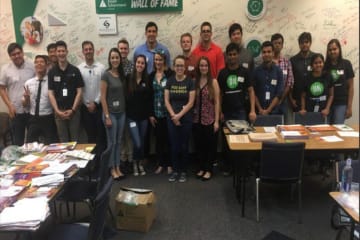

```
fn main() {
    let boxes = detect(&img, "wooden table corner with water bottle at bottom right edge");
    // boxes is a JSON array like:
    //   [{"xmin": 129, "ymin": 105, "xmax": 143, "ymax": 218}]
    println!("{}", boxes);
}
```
[{"xmin": 329, "ymin": 192, "xmax": 359, "ymax": 239}]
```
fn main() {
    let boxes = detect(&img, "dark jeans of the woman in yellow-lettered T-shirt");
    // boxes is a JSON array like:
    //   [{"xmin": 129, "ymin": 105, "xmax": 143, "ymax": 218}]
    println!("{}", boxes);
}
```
[{"xmin": 167, "ymin": 118, "xmax": 192, "ymax": 172}]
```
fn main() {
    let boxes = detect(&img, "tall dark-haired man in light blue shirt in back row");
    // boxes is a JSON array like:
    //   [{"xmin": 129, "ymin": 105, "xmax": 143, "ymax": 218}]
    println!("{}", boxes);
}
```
[{"xmin": 133, "ymin": 22, "xmax": 171, "ymax": 74}]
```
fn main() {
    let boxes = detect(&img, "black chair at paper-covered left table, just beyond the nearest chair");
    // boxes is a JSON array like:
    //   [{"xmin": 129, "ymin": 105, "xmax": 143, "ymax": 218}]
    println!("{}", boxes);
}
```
[{"xmin": 55, "ymin": 145, "xmax": 111, "ymax": 218}]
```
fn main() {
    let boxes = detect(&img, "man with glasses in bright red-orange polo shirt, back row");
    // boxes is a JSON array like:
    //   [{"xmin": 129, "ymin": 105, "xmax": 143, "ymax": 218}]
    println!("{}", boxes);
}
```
[{"xmin": 192, "ymin": 22, "xmax": 225, "ymax": 78}]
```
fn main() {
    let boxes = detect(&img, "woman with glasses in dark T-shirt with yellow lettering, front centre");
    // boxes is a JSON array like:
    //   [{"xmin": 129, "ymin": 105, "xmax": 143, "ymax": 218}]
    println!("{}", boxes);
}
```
[{"xmin": 164, "ymin": 55, "xmax": 195, "ymax": 182}]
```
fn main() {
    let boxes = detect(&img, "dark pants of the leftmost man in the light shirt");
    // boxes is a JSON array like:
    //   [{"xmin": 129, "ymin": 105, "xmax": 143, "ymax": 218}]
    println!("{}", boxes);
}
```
[{"xmin": 10, "ymin": 113, "xmax": 29, "ymax": 146}]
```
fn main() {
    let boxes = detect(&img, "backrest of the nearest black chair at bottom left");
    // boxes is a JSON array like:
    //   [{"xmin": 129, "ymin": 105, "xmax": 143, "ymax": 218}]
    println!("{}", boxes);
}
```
[{"xmin": 87, "ymin": 177, "xmax": 113, "ymax": 240}]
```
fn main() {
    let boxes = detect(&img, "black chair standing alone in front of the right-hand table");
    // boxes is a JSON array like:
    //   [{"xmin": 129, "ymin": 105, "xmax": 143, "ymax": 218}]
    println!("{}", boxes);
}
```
[{"xmin": 256, "ymin": 142, "xmax": 305, "ymax": 223}]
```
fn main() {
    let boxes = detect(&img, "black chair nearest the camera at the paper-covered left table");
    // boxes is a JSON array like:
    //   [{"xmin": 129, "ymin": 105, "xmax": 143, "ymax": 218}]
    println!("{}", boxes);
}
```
[{"xmin": 48, "ymin": 177, "xmax": 113, "ymax": 240}]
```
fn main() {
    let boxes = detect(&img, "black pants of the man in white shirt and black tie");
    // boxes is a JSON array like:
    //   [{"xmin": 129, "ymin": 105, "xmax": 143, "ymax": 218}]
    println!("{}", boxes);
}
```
[{"xmin": 26, "ymin": 114, "xmax": 59, "ymax": 144}]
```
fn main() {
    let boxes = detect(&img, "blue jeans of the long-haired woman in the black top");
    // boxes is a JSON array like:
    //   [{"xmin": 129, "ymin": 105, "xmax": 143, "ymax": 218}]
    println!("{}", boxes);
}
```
[{"xmin": 126, "ymin": 118, "xmax": 148, "ymax": 161}]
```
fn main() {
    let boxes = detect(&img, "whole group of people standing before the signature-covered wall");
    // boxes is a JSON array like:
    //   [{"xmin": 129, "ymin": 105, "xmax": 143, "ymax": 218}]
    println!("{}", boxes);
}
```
[{"xmin": 0, "ymin": 22, "xmax": 354, "ymax": 182}]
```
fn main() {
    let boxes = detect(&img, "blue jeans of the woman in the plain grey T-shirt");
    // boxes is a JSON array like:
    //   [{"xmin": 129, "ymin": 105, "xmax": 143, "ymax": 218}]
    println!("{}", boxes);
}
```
[{"xmin": 102, "ymin": 113, "xmax": 125, "ymax": 167}]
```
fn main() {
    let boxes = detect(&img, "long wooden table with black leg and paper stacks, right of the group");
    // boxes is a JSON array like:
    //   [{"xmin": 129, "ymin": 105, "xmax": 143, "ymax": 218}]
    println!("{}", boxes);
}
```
[{"xmin": 223, "ymin": 124, "xmax": 359, "ymax": 216}]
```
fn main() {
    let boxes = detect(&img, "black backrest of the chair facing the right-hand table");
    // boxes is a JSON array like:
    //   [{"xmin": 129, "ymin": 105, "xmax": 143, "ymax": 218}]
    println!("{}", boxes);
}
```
[{"xmin": 259, "ymin": 142, "xmax": 305, "ymax": 182}]
